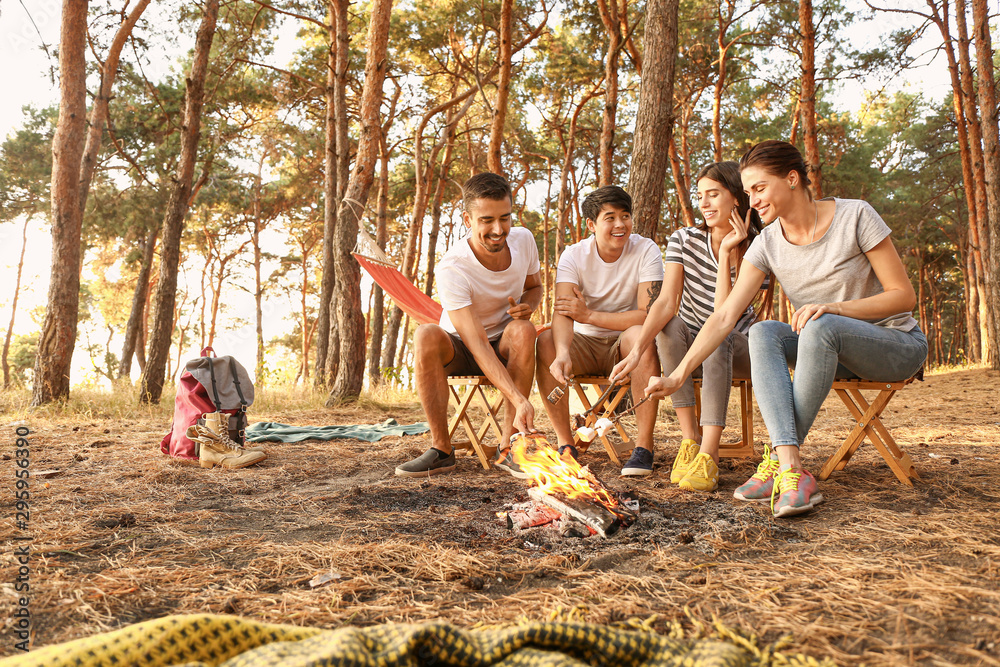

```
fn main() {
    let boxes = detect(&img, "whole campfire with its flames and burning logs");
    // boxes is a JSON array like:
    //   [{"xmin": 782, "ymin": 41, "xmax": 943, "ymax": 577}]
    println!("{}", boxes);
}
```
[{"xmin": 498, "ymin": 433, "xmax": 639, "ymax": 537}]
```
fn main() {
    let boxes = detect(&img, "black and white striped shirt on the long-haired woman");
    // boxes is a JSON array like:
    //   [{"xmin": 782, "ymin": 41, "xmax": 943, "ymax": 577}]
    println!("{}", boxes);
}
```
[{"xmin": 663, "ymin": 227, "xmax": 768, "ymax": 333}]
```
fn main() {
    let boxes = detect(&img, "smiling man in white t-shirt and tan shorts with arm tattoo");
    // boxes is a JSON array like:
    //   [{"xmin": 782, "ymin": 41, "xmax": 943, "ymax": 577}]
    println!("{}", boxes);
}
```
[{"xmin": 537, "ymin": 185, "xmax": 663, "ymax": 475}]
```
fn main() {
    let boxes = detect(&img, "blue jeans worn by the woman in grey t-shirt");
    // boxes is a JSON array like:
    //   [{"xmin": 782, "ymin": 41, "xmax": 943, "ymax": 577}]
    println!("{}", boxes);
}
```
[{"xmin": 750, "ymin": 313, "xmax": 927, "ymax": 447}]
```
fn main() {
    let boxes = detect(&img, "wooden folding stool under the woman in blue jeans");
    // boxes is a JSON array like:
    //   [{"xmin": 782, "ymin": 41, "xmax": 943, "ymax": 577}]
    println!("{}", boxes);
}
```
[{"xmin": 819, "ymin": 378, "xmax": 920, "ymax": 486}]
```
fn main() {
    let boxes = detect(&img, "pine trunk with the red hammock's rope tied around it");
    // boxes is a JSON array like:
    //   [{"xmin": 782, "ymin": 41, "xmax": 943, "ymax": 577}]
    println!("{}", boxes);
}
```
[{"xmin": 327, "ymin": 0, "xmax": 392, "ymax": 405}]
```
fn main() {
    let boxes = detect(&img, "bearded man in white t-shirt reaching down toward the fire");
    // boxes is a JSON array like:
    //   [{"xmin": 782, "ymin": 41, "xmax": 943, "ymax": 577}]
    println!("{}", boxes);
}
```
[{"xmin": 396, "ymin": 173, "xmax": 544, "ymax": 479}]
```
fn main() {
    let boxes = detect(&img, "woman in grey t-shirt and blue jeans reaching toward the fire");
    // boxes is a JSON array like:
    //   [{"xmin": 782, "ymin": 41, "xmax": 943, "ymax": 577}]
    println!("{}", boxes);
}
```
[{"xmin": 646, "ymin": 141, "xmax": 927, "ymax": 517}]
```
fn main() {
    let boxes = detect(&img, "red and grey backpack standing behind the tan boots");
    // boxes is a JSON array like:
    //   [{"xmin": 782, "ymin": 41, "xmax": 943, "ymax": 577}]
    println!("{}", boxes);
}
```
[{"xmin": 160, "ymin": 347, "xmax": 253, "ymax": 461}]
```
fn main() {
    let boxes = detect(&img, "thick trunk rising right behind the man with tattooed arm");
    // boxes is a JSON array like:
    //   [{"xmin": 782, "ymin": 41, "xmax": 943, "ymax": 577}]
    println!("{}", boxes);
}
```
[{"xmin": 628, "ymin": 0, "xmax": 678, "ymax": 239}]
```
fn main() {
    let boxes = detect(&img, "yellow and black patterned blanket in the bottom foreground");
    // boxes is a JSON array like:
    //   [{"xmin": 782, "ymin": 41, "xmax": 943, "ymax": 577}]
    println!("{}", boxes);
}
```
[{"xmin": 3, "ymin": 614, "xmax": 832, "ymax": 667}]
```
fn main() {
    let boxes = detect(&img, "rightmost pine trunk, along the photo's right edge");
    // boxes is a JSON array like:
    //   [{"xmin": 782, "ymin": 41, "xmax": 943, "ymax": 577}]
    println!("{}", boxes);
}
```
[{"xmin": 972, "ymin": 0, "xmax": 1000, "ymax": 370}]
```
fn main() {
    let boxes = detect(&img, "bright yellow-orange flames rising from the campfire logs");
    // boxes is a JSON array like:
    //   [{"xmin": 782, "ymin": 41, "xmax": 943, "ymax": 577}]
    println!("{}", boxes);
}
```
[{"xmin": 511, "ymin": 433, "xmax": 619, "ymax": 509}]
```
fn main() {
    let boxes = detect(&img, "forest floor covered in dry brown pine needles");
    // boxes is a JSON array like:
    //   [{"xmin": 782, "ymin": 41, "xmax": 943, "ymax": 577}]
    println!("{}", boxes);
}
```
[{"xmin": 0, "ymin": 369, "xmax": 1000, "ymax": 665}]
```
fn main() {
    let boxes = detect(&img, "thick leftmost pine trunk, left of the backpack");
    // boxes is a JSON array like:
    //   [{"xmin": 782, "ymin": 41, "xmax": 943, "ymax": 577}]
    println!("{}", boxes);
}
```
[{"xmin": 31, "ymin": 0, "xmax": 88, "ymax": 405}]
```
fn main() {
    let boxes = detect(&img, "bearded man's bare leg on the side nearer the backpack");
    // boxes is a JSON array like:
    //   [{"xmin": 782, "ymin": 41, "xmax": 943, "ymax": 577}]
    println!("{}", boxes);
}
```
[{"xmin": 413, "ymin": 324, "xmax": 455, "ymax": 454}]
